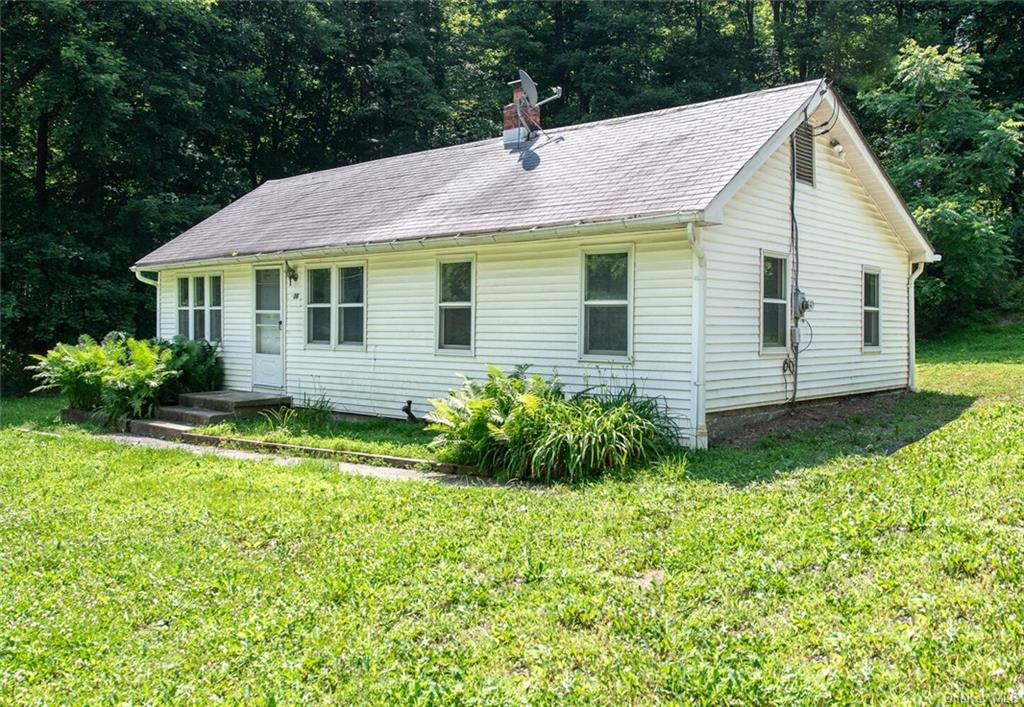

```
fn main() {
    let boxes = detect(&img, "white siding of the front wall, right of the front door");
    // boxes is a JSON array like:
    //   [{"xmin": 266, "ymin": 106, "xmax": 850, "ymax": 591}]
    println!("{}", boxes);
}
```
[{"xmin": 276, "ymin": 233, "xmax": 692, "ymax": 439}]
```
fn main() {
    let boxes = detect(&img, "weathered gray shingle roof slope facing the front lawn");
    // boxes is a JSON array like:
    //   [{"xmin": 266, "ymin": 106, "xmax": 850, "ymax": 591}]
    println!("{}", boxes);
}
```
[{"xmin": 136, "ymin": 80, "xmax": 820, "ymax": 266}]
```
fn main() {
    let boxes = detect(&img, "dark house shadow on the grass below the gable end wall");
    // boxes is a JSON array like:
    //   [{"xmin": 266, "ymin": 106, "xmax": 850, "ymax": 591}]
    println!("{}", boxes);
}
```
[{"xmin": 666, "ymin": 391, "xmax": 976, "ymax": 487}]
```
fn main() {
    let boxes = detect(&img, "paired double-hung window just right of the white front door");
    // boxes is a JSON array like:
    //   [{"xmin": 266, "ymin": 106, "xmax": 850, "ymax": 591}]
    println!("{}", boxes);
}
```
[{"xmin": 306, "ymin": 265, "xmax": 366, "ymax": 345}]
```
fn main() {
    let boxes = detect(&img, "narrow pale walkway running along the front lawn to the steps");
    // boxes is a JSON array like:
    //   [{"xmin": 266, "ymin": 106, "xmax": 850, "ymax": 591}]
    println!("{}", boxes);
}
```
[{"xmin": 97, "ymin": 432, "xmax": 509, "ymax": 489}]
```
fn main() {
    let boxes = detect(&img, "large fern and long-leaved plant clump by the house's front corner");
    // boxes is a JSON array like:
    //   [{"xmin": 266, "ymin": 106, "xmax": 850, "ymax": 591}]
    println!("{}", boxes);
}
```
[{"xmin": 427, "ymin": 366, "xmax": 677, "ymax": 482}]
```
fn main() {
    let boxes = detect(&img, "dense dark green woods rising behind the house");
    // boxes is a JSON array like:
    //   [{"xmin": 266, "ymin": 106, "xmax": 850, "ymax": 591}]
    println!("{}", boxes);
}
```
[{"xmin": 0, "ymin": 0, "xmax": 1024, "ymax": 368}]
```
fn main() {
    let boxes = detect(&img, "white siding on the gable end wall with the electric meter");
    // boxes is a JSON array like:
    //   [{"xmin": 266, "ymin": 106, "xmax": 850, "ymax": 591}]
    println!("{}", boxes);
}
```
[{"xmin": 701, "ymin": 106, "xmax": 908, "ymax": 412}]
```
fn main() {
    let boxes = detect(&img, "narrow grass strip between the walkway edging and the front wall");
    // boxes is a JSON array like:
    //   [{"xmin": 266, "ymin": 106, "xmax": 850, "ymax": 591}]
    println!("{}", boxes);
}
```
[{"xmin": 196, "ymin": 415, "xmax": 436, "ymax": 459}]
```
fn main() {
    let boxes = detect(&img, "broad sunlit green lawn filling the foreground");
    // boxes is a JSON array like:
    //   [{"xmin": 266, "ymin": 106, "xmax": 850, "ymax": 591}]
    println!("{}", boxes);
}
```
[{"xmin": 0, "ymin": 326, "xmax": 1024, "ymax": 705}]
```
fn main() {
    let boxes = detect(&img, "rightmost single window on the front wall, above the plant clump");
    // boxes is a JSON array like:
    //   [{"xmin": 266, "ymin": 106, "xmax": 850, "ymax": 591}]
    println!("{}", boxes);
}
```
[{"xmin": 583, "ymin": 252, "xmax": 630, "ymax": 356}]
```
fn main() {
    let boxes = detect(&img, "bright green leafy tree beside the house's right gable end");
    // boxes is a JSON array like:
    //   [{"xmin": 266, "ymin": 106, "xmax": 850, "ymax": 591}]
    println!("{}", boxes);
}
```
[{"xmin": 862, "ymin": 41, "xmax": 1024, "ymax": 330}]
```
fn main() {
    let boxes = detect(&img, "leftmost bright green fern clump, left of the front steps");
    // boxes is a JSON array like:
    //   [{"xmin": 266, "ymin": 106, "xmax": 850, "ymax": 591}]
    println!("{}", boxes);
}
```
[{"xmin": 29, "ymin": 334, "xmax": 111, "ymax": 410}]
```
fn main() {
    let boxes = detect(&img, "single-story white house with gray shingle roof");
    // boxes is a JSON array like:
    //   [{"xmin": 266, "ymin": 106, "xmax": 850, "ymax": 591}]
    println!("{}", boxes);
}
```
[{"xmin": 133, "ymin": 81, "xmax": 939, "ymax": 446}]
